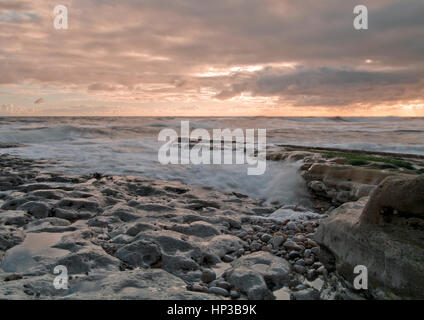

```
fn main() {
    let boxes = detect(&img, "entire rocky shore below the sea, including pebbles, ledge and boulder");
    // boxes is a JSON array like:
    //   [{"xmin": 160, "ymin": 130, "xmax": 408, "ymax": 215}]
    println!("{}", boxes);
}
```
[{"xmin": 0, "ymin": 149, "xmax": 424, "ymax": 300}]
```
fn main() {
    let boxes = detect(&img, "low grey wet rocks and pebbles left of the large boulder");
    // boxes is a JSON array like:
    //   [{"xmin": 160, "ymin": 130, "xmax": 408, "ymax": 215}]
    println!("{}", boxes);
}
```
[{"xmin": 0, "ymin": 153, "xmax": 420, "ymax": 300}]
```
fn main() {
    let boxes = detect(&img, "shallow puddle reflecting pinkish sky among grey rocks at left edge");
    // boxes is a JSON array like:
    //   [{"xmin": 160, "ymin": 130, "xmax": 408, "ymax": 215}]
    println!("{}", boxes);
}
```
[{"xmin": 0, "ymin": 232, "xmax": 69, "ymax": 272}]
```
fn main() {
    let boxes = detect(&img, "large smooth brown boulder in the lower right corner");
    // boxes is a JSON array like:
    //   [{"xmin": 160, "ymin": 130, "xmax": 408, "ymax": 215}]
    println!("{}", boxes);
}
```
[{"xmin": 314, "ymin": 176, "xmax": 424, "ymax": 299}]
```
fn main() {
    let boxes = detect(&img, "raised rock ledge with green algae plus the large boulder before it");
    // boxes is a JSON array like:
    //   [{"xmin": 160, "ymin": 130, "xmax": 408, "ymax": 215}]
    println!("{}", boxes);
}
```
[{"xmin": 269, "ymin": 147, "xmax": 424, "ymax": 299}]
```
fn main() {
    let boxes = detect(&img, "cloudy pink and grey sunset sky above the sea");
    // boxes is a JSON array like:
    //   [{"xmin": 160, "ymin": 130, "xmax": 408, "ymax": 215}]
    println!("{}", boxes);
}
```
[{"xmin": 0, "ymin": 0, "xmax": 424, "ymax": 116}]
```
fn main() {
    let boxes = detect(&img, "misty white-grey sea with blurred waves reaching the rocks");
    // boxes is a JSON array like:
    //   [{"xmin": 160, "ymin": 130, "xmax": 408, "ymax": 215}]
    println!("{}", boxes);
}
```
[{"xmin": 0, "ymin": 117, "xmax": 424, "ymax": 203}]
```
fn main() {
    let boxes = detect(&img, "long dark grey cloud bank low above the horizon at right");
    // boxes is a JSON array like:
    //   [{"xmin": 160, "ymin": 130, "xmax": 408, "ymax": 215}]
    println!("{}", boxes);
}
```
[{"xmin": 216, "ymin": 67, "xmax": 424, "ymax": 106}]
